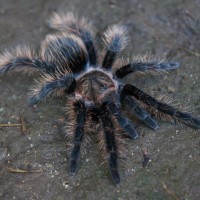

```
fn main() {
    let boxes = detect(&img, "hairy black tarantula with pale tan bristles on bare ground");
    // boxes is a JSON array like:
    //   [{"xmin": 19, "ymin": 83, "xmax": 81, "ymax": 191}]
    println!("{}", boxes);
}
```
[{"xmin": 0, "ymin": 13, "xmax": 200, "ymax": 184}]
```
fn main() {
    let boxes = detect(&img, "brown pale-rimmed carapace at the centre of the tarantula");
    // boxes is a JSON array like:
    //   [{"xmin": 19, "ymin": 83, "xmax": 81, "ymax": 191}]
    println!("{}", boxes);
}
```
[{"xmin": 76, "ymin": 70, "xmax": 116, "ymax": 103}]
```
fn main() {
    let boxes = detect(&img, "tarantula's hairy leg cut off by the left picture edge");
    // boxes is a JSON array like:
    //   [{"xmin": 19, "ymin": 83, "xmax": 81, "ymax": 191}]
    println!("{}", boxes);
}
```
[{"xmin": 0, "ymin": 46, "xmax": 54, "ymax": 74}]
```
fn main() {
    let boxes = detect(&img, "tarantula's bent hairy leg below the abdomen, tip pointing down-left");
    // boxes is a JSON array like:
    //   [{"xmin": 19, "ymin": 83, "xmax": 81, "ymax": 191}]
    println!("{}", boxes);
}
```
[{"xmin": 29, "ymin": 74, "xmax": 76, "ymax": 105}]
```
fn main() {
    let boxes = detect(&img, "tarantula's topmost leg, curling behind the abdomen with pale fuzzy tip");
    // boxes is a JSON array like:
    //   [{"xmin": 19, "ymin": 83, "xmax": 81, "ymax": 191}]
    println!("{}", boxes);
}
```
[{"xmin": 49, "ymin": 12, "xmax": 97, "ymax": 66}]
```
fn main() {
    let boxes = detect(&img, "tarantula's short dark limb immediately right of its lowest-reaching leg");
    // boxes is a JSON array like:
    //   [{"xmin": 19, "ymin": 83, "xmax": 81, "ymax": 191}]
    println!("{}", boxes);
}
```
[{"xmin": 102, "ymin": 94, "xmax": 138, "ymax": 139}]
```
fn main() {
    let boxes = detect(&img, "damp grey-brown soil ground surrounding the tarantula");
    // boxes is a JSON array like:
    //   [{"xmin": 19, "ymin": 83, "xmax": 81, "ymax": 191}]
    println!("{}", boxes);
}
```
[{"xmin": 0, "ymin": 0, "xmax": 200, "ymax": 200}]
